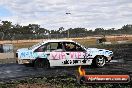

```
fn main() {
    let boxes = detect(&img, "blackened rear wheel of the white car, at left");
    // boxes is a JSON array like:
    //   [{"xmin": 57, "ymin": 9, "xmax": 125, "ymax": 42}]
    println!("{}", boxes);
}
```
[{"xmin": 34, "ymin": 58, "xmax": 50, "ymax": 69}]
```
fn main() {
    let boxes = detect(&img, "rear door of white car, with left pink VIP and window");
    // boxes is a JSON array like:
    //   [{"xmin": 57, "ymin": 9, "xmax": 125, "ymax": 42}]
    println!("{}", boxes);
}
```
[{"xmin": 47, "ymin": 42, "xmax": 66, "ymax": 66}]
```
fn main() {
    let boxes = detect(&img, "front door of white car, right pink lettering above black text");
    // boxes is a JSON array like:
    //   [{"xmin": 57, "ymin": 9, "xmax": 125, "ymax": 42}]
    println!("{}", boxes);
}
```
[{"xmin": 63, "ymin": 42, "xmax": 87, "ymax": 66}]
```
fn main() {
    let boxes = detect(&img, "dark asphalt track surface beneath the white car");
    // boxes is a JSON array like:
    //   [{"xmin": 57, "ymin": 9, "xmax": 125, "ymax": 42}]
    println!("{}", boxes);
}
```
[{"xmin": 0, "ymin": 61, "xmax": 132, "ymax": 82}]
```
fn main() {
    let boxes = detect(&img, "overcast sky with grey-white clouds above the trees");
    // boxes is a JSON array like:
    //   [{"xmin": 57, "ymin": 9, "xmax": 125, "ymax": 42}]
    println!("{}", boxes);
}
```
[{"xmin": 0, "ymin": 0, "xmax": 132, "ymax": 29}]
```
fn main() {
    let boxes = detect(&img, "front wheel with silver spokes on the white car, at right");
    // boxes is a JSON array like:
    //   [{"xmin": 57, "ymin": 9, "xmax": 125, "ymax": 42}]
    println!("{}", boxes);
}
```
[{"xmin": 93, "ymin": 56, "xmax": 106, "ymax": 68}]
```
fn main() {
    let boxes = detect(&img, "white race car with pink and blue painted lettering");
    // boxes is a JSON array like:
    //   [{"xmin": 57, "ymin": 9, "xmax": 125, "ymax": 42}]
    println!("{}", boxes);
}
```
[{"xmin": 16, "ymin": 40, "xmax": 113, "ymax": 68}]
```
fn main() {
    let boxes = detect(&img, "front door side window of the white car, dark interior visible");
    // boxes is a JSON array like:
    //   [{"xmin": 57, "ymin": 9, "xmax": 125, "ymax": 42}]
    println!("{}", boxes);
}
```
[{"xmin": 63, "ymin": 42, "xmax": 85, "ymax": 52}]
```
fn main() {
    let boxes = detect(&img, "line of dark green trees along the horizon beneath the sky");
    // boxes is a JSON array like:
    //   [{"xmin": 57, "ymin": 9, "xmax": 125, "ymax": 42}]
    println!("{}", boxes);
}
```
[{"xmin": 0, "ymin": 21, "xmax": 132, "ymax": 40}]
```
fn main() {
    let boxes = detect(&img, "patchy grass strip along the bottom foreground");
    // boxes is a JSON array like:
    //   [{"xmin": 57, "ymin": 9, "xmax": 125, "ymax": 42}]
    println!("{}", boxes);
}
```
[{"xmin": 0, "ymin": 75, "xmax": 132, "ymax": 88}]
